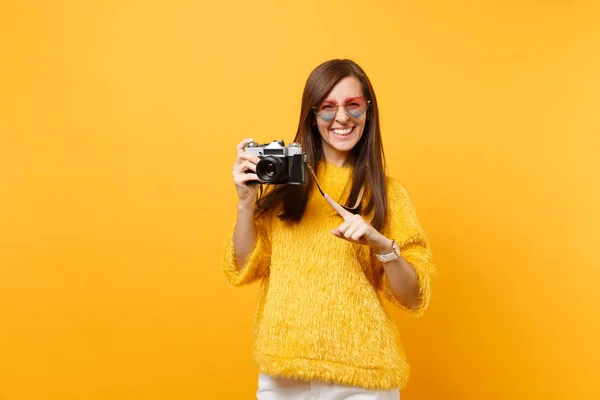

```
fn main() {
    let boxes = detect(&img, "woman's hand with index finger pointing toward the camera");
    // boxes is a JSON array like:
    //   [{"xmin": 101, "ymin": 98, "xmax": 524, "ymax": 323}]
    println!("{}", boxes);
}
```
[{"xmin": 325, "ymin": 194, "xmax": 393, "ymax": 254}]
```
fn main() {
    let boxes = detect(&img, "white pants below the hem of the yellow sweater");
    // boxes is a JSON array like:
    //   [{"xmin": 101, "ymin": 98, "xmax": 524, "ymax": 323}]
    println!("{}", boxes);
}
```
[{"xmin": 256, "ymin": 373, "xmax": 400, "ymax": 400}]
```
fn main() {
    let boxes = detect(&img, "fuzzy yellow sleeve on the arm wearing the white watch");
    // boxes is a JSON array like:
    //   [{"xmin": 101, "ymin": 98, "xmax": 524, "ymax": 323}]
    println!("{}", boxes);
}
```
[{"xmin": 372, "ymin": 179, "xmax": 437, "ymax": 316}]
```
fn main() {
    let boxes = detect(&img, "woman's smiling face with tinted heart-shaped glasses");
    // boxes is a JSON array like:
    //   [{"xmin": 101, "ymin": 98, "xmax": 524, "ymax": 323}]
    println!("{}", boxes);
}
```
[{"xmin": 316, "ymin": 76, "xmax": 368, "ymax": 166}]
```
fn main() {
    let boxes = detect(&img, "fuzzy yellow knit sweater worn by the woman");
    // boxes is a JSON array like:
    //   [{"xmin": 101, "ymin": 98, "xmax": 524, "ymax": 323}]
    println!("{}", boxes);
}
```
[{"xmin": 224, "ymin": 163, "xmax": 435, "ymax": 389}]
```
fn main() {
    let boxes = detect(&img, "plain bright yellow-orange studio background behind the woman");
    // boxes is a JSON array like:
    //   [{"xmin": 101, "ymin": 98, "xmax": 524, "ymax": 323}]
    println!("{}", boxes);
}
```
[{"xmin": 0, "ymin": 0, "xmax": 600, "ymax": 400}]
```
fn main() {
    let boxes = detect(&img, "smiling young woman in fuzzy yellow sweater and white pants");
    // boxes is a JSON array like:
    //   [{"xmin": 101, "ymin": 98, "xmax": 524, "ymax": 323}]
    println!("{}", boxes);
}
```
[{"xmin": 224, "ymin": 60, "xmax": 435, "ymax": 400}]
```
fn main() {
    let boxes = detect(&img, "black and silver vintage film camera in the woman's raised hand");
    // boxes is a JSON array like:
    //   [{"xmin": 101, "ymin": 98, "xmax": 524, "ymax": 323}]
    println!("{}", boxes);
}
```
[{"xmin": 245, "ymin": 140, "xmax": 306, "ymax": 185}]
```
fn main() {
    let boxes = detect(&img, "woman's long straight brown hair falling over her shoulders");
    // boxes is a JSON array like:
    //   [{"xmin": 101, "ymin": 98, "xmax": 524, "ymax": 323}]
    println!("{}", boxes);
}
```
[{"xmin": 257, "ymin": 59, "xmax": 388, "ymax": 231}]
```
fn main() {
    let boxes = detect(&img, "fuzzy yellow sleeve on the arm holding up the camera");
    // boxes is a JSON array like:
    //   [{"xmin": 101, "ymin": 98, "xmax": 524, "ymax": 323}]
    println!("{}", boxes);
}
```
[{"xmin": 223, "ymin": 214, "xmax": 271, "ymax": 286}]
